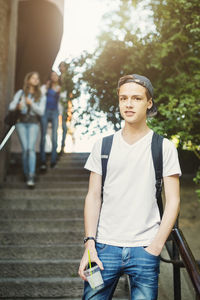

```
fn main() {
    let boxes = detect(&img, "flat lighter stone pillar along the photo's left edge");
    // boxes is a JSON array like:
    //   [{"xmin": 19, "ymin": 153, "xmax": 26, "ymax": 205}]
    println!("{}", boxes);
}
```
[{"xmin": 0, "ymin": 0, "xmax": 18, "ymax": 185}]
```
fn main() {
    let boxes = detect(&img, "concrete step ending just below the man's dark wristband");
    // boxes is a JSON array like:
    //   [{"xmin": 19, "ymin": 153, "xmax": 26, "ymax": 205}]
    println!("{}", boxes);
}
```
[{"xmin": 0, "ymin": 244, "xmax": 84, "ymax": 260}]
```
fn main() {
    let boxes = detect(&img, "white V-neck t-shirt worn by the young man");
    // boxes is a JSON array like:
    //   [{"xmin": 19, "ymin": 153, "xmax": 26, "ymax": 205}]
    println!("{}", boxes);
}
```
[{"xmin": 85, "ymin": 130, "xmax": 181, "ymax": 247}]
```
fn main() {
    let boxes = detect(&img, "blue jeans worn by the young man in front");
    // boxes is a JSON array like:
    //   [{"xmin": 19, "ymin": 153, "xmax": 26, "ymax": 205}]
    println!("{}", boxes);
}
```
[{"xmin": 82, "ymin": 243, "xmax": 160, "ymax": 300}]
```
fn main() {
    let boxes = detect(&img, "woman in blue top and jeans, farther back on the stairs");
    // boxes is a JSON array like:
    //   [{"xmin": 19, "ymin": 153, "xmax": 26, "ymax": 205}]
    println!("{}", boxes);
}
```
[{"xmin": 40, "ymin": 71, "xmax": 61, "ymax": 171}]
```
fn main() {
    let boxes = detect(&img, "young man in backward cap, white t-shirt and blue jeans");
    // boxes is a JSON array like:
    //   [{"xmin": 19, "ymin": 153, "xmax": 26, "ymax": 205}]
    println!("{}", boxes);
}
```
[{"xmin": 79, "ymin": 74, "xmax": 181, "ymax": 300}]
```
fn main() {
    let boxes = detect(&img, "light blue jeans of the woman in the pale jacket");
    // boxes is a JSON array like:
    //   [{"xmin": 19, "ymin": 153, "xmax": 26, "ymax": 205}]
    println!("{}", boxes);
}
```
[{"xmin": 16, "ymin": 123, "xmax": 39, "ymax": 176}]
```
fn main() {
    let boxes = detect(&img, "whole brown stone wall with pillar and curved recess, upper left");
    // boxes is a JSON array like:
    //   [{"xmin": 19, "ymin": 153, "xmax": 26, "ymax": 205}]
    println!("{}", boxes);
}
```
[{"xmin": 0, "ymin": 0, "xmax": 64, "ymax": 186}]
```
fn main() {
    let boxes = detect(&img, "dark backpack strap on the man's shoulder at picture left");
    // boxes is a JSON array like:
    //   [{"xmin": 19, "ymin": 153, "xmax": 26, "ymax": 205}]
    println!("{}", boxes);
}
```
[{"xmin": 101, "ymin": 134, "xmax": 114, "ymax": 198}]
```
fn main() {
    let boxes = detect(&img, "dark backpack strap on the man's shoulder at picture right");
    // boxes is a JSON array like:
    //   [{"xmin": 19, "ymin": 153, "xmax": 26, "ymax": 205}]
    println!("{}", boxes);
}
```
[{"xmin": 151, "ymin": 132, "xmax": 163, "ymax": 218}]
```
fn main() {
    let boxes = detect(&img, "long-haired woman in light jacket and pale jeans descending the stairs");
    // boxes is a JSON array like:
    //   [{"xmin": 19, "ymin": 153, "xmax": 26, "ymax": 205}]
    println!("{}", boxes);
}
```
[{"xmin": 9, "ymin": 72, "xmax": 46, "ymax": 188}]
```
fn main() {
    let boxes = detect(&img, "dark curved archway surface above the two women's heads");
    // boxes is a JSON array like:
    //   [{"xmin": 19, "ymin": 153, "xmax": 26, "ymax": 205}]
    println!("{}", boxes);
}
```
[{"xmin": 15, "ymin": 0, "xmax": 63, "ymax": 90}]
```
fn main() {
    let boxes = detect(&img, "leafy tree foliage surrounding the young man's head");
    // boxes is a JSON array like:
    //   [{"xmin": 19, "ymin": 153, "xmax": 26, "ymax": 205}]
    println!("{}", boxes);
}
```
[{"xmin": 77, "ymin": 0, "xmax": 200, "ymax": 195}]
